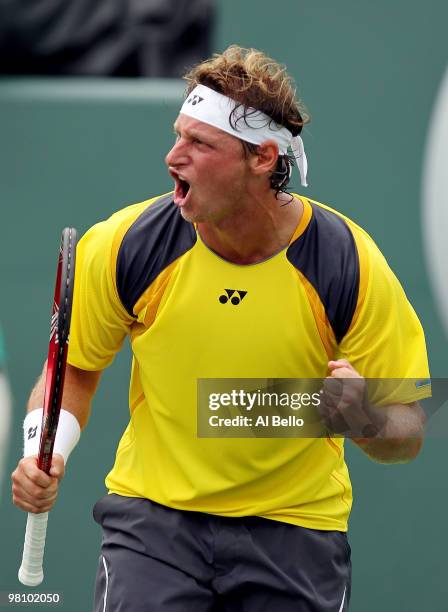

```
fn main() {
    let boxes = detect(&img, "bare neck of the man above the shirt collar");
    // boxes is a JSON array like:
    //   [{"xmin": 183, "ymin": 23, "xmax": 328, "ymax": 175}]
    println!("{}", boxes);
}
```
[{"xmin": 197, "ymin": 194, "xmax": 303, "ymax": 265}]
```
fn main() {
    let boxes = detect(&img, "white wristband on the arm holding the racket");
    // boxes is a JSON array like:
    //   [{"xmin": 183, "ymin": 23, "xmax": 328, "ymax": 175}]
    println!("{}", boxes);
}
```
[{"xmin": 23, "ymin": 408, "xmax": 81, "ymax": 464}]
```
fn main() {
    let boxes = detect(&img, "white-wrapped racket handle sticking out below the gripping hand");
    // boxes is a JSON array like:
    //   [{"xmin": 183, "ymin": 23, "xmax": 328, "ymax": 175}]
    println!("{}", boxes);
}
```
[{"xmin": 19, "ymin": 512, "xmax": 48, "ymax": 586}]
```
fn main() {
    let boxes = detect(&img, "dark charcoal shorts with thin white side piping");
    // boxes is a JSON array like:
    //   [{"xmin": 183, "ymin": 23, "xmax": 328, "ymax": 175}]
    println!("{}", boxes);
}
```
[{"xmin": 93, "ymin": 495, "xmax": 351, "ymax": 612}]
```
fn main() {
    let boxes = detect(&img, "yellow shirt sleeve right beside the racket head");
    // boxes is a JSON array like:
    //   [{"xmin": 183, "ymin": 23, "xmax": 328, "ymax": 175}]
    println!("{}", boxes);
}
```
[{"xmin": 68, "ymin": 220, "xmax": 133, "ymax": 370}]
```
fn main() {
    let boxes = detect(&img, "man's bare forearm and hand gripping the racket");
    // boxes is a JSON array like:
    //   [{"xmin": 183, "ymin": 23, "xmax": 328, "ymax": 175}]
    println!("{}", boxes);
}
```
[{"xmin": 11, "ymin": 363, "xmax": 101, "ymax": 513}]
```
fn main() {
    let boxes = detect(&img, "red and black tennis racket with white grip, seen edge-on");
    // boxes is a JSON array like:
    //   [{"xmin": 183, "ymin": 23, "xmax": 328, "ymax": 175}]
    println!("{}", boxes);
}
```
[{"xmin": 19, "ymin": 227, "xmax": 76, "ymax": 586}]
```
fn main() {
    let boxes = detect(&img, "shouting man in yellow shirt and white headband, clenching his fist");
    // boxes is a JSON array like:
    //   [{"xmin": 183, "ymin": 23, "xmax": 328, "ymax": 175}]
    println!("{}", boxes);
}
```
[{"xmin": 13, "ymin": 47, "xmax": 428, "ymax": 612}]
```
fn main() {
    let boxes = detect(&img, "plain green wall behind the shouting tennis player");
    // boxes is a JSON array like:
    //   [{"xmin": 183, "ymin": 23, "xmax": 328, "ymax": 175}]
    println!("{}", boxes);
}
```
[{"xmin": 0, "ymin": 0, "xmax": 448, "ymax": 612}]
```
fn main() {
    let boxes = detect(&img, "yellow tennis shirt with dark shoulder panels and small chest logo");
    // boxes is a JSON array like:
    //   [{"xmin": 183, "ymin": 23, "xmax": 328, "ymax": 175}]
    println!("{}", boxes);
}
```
[{"xmin": 69, "ymin": 194, "xmax": 429, "ymax": 531}]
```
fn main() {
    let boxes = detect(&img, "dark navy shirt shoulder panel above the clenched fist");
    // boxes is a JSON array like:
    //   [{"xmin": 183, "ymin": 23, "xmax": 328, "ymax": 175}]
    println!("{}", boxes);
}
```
[{"xmin": 286, "ymin": 204, "xmax": 359, "ymax": 343}]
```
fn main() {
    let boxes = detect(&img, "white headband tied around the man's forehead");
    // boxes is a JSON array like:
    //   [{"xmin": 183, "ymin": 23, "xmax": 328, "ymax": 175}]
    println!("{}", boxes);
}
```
[{"xmin": 180, "ymin": 85, "xmax": 308, "ymax": 187}]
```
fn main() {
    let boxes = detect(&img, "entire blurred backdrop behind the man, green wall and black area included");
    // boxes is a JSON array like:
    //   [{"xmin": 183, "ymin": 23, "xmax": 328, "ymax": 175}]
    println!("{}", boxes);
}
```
[{"xmin": 0, "ymin": 0, "xmax": 448, "ymax": 612}]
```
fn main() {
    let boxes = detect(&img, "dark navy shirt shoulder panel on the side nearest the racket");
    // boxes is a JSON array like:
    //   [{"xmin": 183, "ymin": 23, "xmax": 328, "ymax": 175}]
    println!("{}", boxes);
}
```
[{"xmin": 117, "ymin": 194, "xmax": 196, "ymax": 316}]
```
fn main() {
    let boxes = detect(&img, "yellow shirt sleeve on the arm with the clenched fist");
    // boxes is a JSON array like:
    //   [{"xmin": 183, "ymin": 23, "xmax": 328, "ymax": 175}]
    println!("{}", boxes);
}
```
[{"xmin": 338, "ymin": 237, "xmax": 431, "ymax": 405}]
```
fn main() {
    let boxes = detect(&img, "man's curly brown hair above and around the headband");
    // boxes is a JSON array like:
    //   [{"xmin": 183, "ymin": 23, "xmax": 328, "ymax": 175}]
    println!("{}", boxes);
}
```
[{"xmin": 184, "ymin": 45, "xmax": 310, "ymax": 194}]
